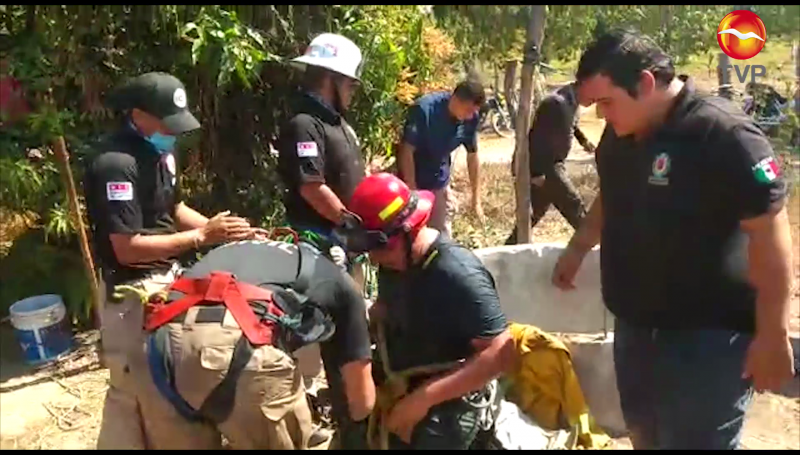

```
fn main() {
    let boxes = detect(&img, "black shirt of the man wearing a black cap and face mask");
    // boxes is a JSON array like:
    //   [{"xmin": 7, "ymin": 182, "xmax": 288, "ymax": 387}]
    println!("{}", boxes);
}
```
[{"xmin": 83, "ymin": 126, "xmax": 181, "ymax": 283}]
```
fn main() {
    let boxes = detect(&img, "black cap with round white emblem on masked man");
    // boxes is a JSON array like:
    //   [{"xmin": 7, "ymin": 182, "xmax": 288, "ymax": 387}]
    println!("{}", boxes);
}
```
[{"xmin": 107, "ymin": 73, "xmax": 200, "ymax": 134}]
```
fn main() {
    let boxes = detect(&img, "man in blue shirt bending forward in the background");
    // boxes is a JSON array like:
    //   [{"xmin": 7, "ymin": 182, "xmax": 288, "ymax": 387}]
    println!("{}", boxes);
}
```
[{"xmin": 397, "ymin": 80, "xmax": 486, "ymax": 236}]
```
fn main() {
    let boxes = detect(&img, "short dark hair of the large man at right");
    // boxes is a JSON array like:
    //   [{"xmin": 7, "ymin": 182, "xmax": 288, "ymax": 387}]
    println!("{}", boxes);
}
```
[{"xmin": 575, "ymin": 30, "xmax": 675, "ymax": 98}]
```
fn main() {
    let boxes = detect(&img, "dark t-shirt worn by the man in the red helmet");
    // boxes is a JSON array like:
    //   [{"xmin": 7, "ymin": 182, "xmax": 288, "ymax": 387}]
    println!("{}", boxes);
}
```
[{"xmin": 378, "ymin": 234, "xmax": 508, "ymax": 371}]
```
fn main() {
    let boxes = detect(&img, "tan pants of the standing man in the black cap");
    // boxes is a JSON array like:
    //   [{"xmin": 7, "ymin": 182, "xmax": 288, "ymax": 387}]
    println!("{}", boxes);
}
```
[{"xmin": 97, "ymin": 264, "xmax": 180, "ymax": 450}]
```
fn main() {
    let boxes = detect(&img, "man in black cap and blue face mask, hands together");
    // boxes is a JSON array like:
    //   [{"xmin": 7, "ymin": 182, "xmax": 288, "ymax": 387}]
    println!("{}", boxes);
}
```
[{"xmin": 84, "ymin": 73, "xmax": 255, "ymax": 449}]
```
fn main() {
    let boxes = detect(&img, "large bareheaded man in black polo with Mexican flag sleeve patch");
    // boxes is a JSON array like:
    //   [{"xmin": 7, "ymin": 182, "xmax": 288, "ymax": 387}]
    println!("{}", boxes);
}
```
[{"xmin": 553, "ymin": 32, "xmax": 793, "ymax": 449}]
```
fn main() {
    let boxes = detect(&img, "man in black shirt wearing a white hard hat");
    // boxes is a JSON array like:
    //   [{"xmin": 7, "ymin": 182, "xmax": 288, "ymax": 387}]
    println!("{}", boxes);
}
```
[{"xmin": 278, "ymin": 33, "xmax": 365, "ymax": 281}]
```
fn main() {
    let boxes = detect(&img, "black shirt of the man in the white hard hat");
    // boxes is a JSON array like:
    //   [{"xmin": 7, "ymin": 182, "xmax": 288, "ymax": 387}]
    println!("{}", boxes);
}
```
[{"xmin": 278, "ymin": 93, "xmax": 365, "ymax": 229}]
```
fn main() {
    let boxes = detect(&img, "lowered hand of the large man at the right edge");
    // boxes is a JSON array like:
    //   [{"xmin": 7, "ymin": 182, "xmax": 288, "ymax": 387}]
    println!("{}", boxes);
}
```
[{"xmin": 742, "ymin": 333, "xmax": 794, "ymax": 392}]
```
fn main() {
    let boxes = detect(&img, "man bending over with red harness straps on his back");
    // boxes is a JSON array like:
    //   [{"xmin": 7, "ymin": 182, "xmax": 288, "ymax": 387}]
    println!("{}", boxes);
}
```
[{"xmin": 134, "ymin": 240, "xmax": 375, "ymax": 450}]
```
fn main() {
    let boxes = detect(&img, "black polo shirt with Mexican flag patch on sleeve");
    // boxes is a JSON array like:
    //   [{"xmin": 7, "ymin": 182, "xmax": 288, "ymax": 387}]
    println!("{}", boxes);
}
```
[{"xmin": 596, "ymin": 77, "xmax": 786, "ymax": 331}]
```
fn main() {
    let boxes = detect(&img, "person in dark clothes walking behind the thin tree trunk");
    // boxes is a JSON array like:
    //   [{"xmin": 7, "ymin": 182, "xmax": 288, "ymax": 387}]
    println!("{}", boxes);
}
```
[{"xmin": 506, "ymin": 82, "xmax": 594, "ymax": 245}]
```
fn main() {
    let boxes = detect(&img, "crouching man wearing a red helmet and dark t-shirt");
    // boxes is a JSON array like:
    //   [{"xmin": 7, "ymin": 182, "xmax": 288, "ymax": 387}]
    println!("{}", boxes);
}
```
[{"xmin": 336, "ymin": 173, "xmax": 514, "ymax": 449}]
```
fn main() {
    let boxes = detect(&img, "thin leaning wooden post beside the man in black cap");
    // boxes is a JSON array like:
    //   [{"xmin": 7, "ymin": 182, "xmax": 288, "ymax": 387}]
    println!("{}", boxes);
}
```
[{"xmin": 53, "ymin": 136, "xmax": 103, "ymax": 328}]
